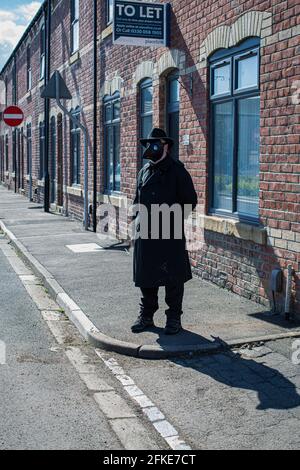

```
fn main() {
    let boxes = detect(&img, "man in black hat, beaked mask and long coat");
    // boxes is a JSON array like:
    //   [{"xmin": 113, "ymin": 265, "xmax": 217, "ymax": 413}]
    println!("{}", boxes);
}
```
[{"xmin": 132, "ymin": 128, "xmax": 197, "ymax": 335}]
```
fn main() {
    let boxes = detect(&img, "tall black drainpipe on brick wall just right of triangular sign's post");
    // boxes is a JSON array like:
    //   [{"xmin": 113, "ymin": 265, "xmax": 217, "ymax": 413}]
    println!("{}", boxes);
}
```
[{"xmin": 93, "ymin": 0, "xmax": 98, "ymax": 232}]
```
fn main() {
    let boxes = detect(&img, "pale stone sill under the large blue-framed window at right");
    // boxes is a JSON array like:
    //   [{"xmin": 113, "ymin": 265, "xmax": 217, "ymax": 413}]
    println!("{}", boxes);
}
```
[{"xmin": 204, "ymin": 216, "xmax": 267, "ymax": 245}]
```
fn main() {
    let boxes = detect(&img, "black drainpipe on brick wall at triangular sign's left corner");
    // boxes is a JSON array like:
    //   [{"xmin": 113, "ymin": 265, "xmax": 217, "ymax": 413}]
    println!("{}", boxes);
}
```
[{"xmin": 44, "ymin": 0, "xmax": 51, "ymax": 212}]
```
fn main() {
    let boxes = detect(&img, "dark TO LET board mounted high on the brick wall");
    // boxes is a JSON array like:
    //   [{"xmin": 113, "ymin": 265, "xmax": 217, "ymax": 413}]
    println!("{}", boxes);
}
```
[{"xmin": 114, "ymin": 0, "xmax": 170, "ymax": 47}]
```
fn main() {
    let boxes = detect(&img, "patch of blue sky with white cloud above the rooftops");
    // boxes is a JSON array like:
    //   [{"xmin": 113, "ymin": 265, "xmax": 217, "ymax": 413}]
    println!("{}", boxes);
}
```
[{"xmin": 0, "ymin": 0, "xmax": 42, "ymax": 70}]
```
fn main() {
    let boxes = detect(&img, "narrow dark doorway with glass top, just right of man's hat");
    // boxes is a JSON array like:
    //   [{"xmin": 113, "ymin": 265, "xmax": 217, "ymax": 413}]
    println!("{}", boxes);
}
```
[{"xmin": 167, "ymin": 71, "xmax": 180, "ymax": 159}]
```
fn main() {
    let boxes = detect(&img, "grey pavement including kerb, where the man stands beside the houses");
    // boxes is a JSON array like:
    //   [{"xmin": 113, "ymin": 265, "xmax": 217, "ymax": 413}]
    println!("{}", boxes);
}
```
[{"xmin": 0, "ymin": 187, "xmax": 300, "ymax": 359}]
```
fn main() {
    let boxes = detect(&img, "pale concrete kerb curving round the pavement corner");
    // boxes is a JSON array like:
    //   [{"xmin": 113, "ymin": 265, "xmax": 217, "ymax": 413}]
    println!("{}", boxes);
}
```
[{"xmin": 0, "ymin": 220, "xmax": 300, "ymax": 359}]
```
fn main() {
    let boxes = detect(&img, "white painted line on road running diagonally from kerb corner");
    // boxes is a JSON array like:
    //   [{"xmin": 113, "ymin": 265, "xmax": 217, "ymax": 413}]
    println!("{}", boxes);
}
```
[{"xmin": 96, "ymin": 349, "xmax": 192, "ymax": 450}]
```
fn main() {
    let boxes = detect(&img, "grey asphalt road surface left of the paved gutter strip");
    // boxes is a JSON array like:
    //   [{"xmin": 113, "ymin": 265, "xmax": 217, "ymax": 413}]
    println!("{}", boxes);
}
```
[{"xmin": 0, "ymin": 250, "xmax": 121, "ymax": 450}]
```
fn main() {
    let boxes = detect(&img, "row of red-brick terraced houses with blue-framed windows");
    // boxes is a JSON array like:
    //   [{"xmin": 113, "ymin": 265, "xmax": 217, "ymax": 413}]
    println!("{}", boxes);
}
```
[{"xmin": 0, "ymin": 0, "xmax": 300, "ymax": 313}]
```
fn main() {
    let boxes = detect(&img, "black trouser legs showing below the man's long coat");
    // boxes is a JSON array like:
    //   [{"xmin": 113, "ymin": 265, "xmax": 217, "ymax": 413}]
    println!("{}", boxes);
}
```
[{"xmin": 141, "ymin": 283, "xmax": 184, "ymax": 318}]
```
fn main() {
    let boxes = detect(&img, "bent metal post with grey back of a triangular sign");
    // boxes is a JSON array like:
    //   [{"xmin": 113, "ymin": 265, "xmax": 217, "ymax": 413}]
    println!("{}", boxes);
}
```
[{"xmin": 41, "ymin": 71, "xmax": 89, "ymax": 230}]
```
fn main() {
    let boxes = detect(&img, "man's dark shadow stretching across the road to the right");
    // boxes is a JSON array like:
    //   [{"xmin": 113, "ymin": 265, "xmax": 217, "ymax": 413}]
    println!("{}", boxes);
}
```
[{"xmin": 157, "ymin": 329, "xmax": 300, "ymax": 410}]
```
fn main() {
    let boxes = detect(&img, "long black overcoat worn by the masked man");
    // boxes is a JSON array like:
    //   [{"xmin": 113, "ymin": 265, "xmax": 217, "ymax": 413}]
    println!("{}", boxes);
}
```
[{"xmin": 134, "ymin": 156, "xmax": 197, "ymax": 288}]
